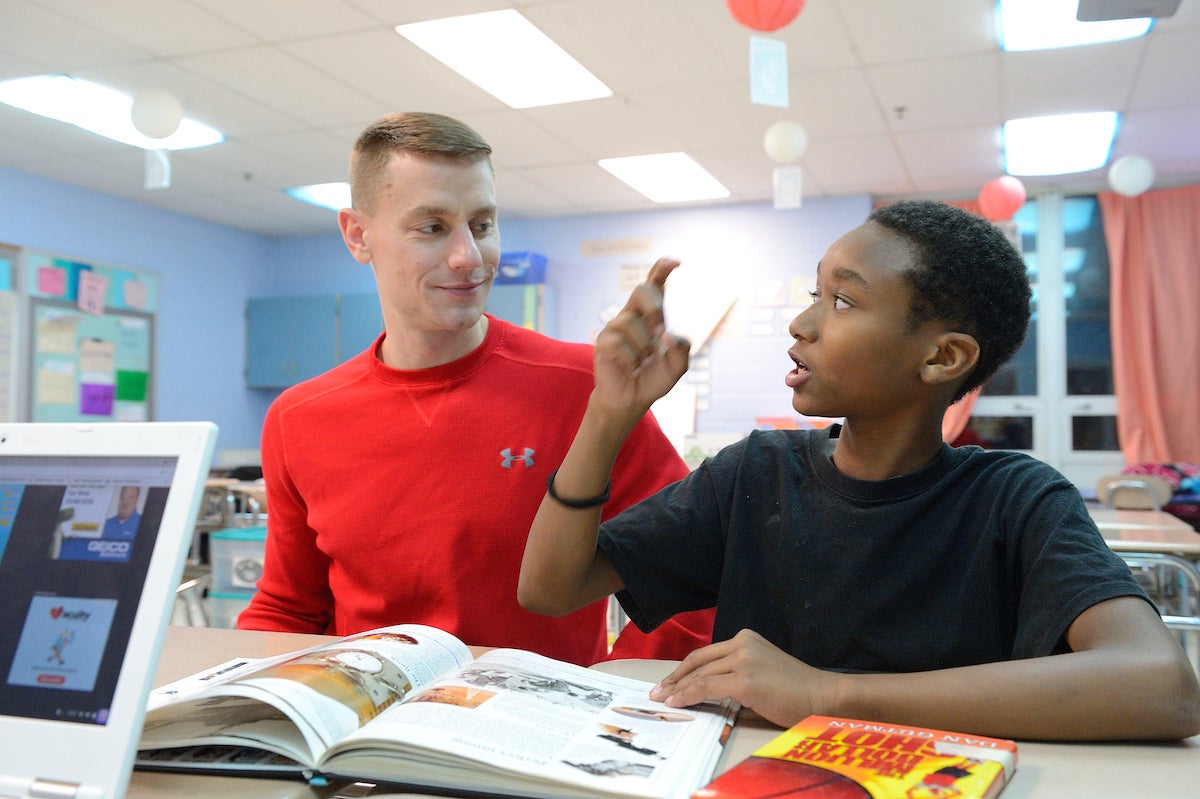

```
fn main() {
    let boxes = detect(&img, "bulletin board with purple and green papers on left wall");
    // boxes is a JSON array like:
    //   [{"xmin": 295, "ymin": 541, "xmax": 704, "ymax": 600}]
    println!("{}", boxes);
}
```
[{"xmin": 25, "ymin": 252, "xmax": 157, "ymax": 422}]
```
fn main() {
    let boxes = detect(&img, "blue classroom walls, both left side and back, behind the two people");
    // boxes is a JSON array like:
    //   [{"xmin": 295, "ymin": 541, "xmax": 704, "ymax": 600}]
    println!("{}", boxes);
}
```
[{"xmin": 0, "ymin": 168, "xmax": 871, "ymax": 449}]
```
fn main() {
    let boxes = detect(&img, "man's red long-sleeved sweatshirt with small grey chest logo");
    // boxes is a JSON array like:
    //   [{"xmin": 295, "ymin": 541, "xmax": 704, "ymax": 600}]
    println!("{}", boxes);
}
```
[{"xmin": 238, "ymin": 318, "xmax": 712, "ymax": 665}]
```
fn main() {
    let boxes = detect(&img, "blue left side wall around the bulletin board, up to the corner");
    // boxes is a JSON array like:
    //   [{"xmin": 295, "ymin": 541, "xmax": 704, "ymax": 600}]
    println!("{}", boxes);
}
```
[{"xmin": 0, "ymin": 168, "xmax": 272, "ymax": 449}]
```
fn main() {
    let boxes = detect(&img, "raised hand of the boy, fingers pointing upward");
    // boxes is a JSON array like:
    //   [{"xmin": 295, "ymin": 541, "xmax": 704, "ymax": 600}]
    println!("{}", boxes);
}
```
[{"xmin": 593, "ymin": 258, "xmax": 690, "ymax": 417}]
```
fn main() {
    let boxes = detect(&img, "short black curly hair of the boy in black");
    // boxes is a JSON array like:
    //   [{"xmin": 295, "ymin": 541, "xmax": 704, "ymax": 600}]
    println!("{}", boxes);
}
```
[{"xmin": 868, "ymin": 200, "xmax": 1031, "ymax": 401}]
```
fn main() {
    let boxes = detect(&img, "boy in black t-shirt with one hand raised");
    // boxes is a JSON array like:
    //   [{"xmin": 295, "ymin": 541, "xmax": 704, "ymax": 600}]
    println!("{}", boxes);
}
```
[{"xmin": 518, "ymin": 202, "xmax": 1200, "ymax": 740}]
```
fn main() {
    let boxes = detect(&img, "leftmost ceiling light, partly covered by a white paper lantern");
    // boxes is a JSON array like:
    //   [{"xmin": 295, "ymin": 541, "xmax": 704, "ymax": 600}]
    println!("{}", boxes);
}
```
[{"xmin": 0, "ymin": 74, "xmax": 224, "ymax": 150}]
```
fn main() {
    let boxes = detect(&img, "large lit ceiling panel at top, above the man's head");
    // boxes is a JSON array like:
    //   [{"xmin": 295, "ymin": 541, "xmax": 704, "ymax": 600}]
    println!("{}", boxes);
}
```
[{"xmin": 396, "ymin": 8, "xmax": 612, "ymax": 108}]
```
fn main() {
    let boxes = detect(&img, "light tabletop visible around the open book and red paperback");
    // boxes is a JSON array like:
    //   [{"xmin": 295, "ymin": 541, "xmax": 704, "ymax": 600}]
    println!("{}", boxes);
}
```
[{"xmin": 127, "ymin": 626, "xmax": 1200, "ymax": 799}]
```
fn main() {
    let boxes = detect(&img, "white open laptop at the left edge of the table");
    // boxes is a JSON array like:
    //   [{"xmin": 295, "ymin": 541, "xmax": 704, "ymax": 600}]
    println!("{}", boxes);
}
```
[{"xmin": 0, "ymin": 422, "xmax": 217, "ymax": 799}]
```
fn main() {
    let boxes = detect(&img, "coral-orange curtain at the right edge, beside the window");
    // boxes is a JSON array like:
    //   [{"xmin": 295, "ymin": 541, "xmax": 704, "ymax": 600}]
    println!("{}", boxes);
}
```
[{"xmin": 1098, "ymin": 186, "xmax": 1200, "ymax": 464}]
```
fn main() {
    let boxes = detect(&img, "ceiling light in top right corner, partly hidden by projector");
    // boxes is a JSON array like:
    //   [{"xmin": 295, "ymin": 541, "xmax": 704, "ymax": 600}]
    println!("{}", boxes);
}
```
[{"xmin": 996, "ymin": 0, "xmax": 1153, "ymax": 52}]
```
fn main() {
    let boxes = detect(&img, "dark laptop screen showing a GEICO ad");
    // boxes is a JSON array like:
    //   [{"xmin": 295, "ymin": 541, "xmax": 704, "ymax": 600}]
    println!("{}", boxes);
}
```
[{"xmin": 0, "ymin": 455, "xmax": 178, "ymax": 725}]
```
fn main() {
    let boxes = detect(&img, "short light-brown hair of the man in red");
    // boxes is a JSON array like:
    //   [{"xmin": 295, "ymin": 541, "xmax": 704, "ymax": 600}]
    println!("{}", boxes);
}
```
[{"xmin": 350, "ymin": 112, "xmax": 492, "ymax": 214}]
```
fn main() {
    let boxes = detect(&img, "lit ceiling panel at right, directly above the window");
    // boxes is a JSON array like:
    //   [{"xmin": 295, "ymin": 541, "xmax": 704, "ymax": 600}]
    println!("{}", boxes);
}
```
[{"xmin": 1004, "ymin": 112, "xmax": 1118, "ymax": 175}]
